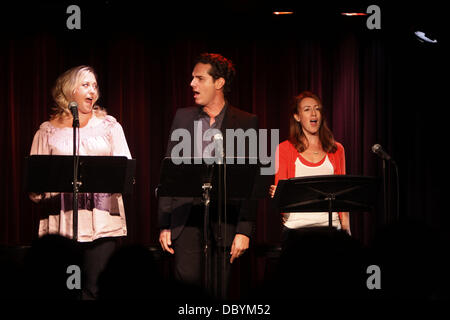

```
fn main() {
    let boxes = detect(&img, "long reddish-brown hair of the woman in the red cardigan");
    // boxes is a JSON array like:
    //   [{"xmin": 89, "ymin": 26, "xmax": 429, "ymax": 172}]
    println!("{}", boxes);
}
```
[{"xmin": 289, "ymin": 91, "xmax": 337, "ymax": 153}]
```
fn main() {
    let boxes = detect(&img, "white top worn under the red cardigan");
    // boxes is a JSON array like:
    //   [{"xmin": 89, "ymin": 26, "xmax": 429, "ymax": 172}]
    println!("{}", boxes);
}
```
[{"xmin": 283, "ymin": 155, "xmax": 340, "ymax": 229}]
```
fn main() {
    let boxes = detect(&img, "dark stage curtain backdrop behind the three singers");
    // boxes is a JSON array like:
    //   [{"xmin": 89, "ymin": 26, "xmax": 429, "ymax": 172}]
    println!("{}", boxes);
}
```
[{"xmin": 0, "ymin": 1, "xmax": 450, "ymax": 298}]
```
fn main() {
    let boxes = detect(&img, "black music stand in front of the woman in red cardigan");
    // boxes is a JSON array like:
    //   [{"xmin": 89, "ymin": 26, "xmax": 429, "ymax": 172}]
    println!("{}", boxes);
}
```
[{"xmin": 274, "ymin": 175, "xmax": 378, "ymax": 227}]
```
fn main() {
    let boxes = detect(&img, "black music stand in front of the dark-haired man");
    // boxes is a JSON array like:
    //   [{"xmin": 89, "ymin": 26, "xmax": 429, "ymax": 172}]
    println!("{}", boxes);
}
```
[{"xmin": 157, "ymin": 157, "xmax": 262, "ymax": 295}]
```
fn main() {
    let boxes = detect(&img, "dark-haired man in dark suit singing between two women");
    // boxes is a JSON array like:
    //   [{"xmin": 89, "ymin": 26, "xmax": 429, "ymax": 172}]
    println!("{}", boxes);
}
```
[{"xmin": 158, "ymin": 53, "xmax": 258, "ymax": 298}]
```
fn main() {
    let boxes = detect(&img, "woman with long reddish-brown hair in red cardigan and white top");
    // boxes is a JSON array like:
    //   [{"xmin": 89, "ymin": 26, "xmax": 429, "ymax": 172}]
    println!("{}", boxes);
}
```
[{"xmin": 270, "ymin": 91, "xmax": 350, "ymax": 234}]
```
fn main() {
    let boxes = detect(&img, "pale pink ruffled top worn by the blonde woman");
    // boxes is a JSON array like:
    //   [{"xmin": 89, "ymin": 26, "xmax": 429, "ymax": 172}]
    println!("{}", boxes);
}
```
[{"xmin": 30, "ymin": 115, "xmax": 131, "ymax": 242}]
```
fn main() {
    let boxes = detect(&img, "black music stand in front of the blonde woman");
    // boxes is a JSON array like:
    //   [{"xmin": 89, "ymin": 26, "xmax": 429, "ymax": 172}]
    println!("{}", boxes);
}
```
[{"xmin": 23, "ymin": 155, "xmax": 136, "ymax": 240}]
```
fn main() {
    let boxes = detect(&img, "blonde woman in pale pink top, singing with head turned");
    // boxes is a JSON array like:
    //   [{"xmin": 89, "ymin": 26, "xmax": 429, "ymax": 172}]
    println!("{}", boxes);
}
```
[{"xmin": 30, "ymin": 66, "xmax": 131, "ymax": 299}]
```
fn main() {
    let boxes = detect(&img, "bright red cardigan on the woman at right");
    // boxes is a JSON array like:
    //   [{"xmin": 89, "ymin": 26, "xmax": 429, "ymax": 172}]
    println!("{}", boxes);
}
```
[{"xmin": 275, "ymin": 140, "xmax": 345, "ymax": 219}]
